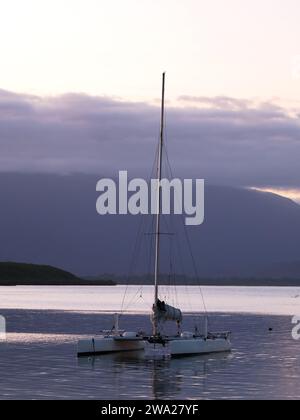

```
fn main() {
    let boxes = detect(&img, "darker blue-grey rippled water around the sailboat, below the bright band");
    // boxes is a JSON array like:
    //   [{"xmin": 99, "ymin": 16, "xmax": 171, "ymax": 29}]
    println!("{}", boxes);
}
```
[{"xmin": 0, "ymin": 309, "xmax": 300, "ymax": 400}]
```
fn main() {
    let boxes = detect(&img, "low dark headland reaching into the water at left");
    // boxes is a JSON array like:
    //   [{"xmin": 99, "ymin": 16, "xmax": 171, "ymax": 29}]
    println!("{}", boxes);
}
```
[{"xmin": 0, "ymin": 262, "xmax": 115, "ymax": 286}]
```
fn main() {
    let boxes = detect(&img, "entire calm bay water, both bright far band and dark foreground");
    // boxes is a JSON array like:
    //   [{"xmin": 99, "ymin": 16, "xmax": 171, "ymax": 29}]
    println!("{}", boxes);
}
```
[{"xmin": 0, "ymin": 287, "xmax": 300, "ymax": 399}]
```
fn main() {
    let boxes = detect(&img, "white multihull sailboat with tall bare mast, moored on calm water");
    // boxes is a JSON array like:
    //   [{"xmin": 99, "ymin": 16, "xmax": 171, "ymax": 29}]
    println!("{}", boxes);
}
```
[{"xmin": 78, "ymin": 73, "xmax": 232, "ymax": 358}]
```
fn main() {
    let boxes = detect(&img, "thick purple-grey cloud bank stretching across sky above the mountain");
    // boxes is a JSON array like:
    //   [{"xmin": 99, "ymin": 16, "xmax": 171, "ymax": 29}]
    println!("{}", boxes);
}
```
[{"xmin": 0, "ymin": 90, "xmax": 300, "ymax": 187}]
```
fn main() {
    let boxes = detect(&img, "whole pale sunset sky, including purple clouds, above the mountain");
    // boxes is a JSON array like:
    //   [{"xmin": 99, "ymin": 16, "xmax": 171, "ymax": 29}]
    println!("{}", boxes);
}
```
[{"xmin": 0, "ymin": 0, "xmax": 300, "ymax": 202}]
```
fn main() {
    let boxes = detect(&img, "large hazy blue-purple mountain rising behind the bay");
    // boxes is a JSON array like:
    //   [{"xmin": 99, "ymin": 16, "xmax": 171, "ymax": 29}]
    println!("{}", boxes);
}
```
[{"xmin": 0, "ymin": 174, "xmax": 300, "ymax": 278}]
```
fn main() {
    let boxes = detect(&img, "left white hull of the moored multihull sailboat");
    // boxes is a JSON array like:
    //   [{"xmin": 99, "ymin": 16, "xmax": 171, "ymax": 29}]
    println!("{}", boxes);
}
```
[{"xmin": 77, "ymin": 336, "xmax": 144, "ymax": 356}]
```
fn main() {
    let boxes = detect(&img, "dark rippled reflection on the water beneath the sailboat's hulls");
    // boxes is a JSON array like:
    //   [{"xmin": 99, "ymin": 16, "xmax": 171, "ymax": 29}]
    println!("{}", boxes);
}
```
[{"xmin": 78, "ymin": 352, "xmax": 233, "ymax": 399}]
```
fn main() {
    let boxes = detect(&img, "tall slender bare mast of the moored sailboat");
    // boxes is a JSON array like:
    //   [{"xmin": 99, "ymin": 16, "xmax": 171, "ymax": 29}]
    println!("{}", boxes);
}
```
[{"xmin": 153, "ymin": 73, "xmax": 166, "ymax": 336}]
